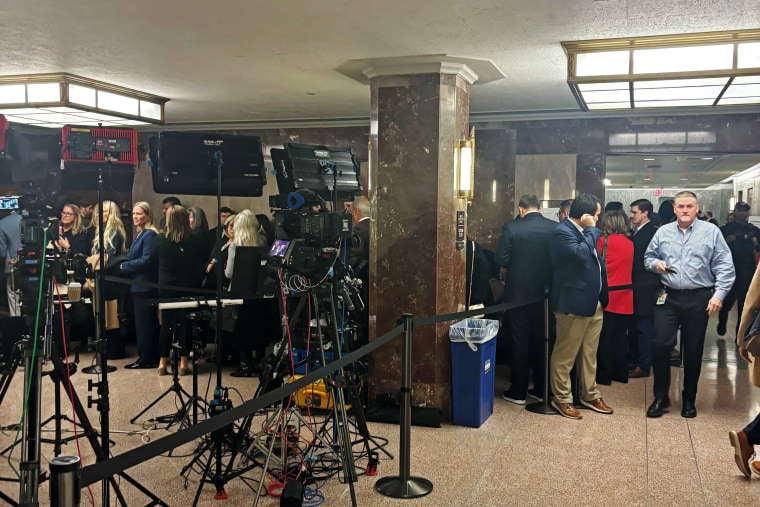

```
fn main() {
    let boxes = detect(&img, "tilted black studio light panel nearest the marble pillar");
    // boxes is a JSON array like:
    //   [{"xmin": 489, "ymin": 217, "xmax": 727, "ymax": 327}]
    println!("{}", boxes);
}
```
[{"xmin": 270, "ymin": 143, "xmax": 362, "ymax": 201}]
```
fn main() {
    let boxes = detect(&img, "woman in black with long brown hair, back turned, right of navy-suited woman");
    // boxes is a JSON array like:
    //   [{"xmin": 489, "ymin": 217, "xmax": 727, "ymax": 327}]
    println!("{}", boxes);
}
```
[{"xmin": 151, "ymin": 205, "xmax": 205, "ymax": 375}]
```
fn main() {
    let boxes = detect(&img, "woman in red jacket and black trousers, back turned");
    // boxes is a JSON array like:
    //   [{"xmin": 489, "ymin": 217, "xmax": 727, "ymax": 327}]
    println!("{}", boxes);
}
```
[{"xmin": 596, "ymin": 211, "xmax": 633, "ymax": 385}]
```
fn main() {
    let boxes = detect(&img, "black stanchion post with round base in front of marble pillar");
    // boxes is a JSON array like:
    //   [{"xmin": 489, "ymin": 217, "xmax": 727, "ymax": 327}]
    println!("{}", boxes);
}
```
[{"xmin": 375, "ymin": 313, "xmax": 433, "ymax": 498}]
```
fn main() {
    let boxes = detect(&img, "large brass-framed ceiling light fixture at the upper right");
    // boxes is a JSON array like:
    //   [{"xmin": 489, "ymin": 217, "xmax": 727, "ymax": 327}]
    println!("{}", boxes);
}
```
[{"xmin": 562, "ymin": 29, "xmax": 760, "ymax": 111}]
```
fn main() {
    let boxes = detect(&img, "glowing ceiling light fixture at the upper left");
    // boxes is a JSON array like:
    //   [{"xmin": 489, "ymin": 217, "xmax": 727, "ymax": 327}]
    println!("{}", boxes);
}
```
[{"xmin": 0, "ymin": 73, "xmax": 169, "ymax": 128}]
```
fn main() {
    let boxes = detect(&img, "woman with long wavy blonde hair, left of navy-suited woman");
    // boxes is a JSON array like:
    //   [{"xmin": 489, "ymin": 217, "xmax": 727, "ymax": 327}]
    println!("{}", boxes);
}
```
[{"xmin": 87, "ymin": 201, "xmax": 127, "ymax": 359}]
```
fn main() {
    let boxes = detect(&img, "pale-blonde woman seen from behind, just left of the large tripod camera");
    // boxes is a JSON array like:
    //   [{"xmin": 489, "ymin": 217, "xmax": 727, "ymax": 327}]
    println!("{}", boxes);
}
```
[{"xmin": 224, "ymin": 209, "xmax": 271, "ymax": 377}]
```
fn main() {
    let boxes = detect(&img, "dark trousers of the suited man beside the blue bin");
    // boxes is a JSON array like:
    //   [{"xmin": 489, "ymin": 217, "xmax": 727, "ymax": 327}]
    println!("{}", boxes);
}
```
[{"xmin": 506, "ymin": 301, "xmax": 546, "ymax": 400}]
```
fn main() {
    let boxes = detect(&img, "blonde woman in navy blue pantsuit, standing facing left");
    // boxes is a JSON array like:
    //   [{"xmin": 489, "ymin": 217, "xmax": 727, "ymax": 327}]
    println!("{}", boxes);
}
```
[{"xmin": 121, "ymin": 201, "xmax": 159, "ymax": 369}]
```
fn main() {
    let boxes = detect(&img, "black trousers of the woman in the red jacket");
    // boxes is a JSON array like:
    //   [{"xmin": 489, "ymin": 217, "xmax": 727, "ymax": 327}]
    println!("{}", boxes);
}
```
[{"xmin": 596, "ymin": 312, "xmax": 631, "ymax": 384}]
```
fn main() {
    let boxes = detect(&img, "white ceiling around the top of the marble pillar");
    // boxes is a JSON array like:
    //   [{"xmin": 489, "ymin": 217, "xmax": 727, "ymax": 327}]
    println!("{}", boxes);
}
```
[{"xmin": 0, "ymin": 0, "xmax": 760, "ymax": 123}]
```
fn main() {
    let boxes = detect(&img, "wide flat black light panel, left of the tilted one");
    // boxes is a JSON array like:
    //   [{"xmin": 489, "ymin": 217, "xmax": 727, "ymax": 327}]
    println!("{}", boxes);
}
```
[{"xmin": 149, "ymin": 132, "xmax": 267, "ymax": 197}]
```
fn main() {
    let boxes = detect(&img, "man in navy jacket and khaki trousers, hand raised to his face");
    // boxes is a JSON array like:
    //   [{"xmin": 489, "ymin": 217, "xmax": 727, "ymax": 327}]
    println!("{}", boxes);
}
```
[{"xmin": 550, "ymin": 194, "xmax": 612, "ymax": 419}]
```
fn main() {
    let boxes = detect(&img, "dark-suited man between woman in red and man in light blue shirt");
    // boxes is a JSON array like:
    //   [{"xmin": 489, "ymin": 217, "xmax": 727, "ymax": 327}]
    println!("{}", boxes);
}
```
[{"xmin": 628, "ymin": 199, "xmax": 660, "ymax": 378}]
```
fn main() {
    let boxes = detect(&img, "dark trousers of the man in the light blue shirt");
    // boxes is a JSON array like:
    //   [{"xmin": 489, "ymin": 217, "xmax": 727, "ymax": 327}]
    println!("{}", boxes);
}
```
[{"xmin": 653, "ymin": 289, "xmax": 712, "ymax": 401}]
